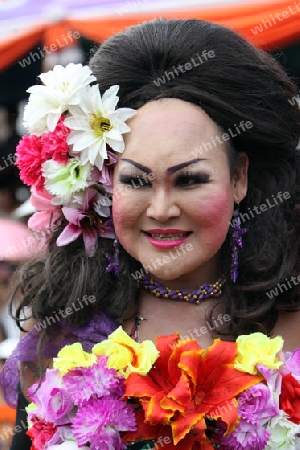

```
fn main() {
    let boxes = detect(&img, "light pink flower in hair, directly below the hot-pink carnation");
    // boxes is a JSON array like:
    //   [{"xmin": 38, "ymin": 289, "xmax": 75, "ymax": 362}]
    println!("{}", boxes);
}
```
[{"xmin": 28, "ymin": 186, "xmax": 61, "ymax": 231}]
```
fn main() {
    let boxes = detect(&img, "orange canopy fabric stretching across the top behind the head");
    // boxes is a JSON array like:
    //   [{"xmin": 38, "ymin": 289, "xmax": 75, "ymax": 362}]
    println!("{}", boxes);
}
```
[{"xmin": 0, "ymin": 0, "xmax": 300, "ymax": 69}]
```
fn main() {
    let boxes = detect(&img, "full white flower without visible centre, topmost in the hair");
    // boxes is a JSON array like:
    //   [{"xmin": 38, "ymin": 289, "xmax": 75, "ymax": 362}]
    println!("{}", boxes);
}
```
[{"xmin": 24, "ymin": 63, "xmax": 96, "ymax": 135}]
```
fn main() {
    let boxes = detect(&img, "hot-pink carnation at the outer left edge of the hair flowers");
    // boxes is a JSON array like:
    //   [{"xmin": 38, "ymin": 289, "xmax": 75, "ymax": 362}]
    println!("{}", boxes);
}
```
[{"xmin": 16, "ymin": 135, "xmax": 47, "ymax": 189}]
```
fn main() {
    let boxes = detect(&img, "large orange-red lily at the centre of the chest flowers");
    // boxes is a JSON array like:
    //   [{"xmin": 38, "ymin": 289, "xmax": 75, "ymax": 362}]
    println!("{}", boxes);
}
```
[{"xmin": 125, "ymin": 334, "xmax": 262, "ymax": 450}]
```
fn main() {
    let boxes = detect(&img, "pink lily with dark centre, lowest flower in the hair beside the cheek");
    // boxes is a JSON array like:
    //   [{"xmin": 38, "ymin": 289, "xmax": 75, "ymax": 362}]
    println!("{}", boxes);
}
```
[{"xmin": 56, "ymin": 188, "xmax": 115, "ymax": 256}]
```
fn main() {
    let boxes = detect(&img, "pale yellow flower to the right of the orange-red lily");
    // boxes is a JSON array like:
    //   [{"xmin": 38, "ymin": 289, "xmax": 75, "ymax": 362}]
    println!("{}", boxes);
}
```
[{"xmin": 234, "ymin": 333, "xmax": 283, "ymax": 375}]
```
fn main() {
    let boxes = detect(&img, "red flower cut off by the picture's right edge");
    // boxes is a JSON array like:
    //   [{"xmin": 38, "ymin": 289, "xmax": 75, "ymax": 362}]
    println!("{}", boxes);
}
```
[{"xmin": 279, "ymin": 373, "xmax": 300, "ymax": 424}]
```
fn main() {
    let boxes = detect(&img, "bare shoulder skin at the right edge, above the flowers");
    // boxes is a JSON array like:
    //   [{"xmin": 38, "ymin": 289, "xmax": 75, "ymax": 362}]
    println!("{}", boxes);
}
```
[{"xmin": 272, "ymin": 310, "xmax": 300, "ymax": 351}]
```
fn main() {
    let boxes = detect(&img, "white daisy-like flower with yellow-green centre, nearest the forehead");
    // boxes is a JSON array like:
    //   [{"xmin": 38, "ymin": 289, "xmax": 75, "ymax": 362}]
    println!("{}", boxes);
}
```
[{"xmin": 65, "ymin": 86, "xmax": 136, "ymax": 170}]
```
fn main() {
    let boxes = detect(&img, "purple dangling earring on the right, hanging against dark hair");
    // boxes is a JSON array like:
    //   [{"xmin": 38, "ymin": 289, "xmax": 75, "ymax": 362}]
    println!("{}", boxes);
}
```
[{"xmin": 229, "ymin": 207, "xmax": 248, "ymax": 283}]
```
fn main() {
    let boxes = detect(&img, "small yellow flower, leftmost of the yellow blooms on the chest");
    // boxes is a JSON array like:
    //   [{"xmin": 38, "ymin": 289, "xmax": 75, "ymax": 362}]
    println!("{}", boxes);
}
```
[{"xmin": 53, "ymin": 342, "xmax": 97, "ymax": 375}]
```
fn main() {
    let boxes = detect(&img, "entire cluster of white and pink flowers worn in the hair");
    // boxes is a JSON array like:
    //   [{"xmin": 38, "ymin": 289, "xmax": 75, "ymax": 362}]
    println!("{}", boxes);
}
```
[{"xmin": 16, "ymin": 64, "xmax": 136, "ymax": 256}]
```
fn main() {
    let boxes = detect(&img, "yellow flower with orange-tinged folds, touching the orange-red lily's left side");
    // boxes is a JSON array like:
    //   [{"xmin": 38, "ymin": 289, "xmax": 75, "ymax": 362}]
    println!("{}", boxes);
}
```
[{"xmin": 92, "ymin": 327, "xmax": 159, "ymax": 378}]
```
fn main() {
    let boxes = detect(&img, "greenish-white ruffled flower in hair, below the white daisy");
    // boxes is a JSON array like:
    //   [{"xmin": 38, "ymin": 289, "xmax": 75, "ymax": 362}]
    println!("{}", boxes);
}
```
[{"xmin": 42, "ymin": 158, "xmax": 92, "ymax": 205}]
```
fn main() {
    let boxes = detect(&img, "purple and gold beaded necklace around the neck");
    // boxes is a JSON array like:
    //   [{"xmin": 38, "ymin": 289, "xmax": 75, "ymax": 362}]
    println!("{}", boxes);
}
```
[{"xmin": 138, "ymin": 275, "xmax": 226, "ymax": 305}]
